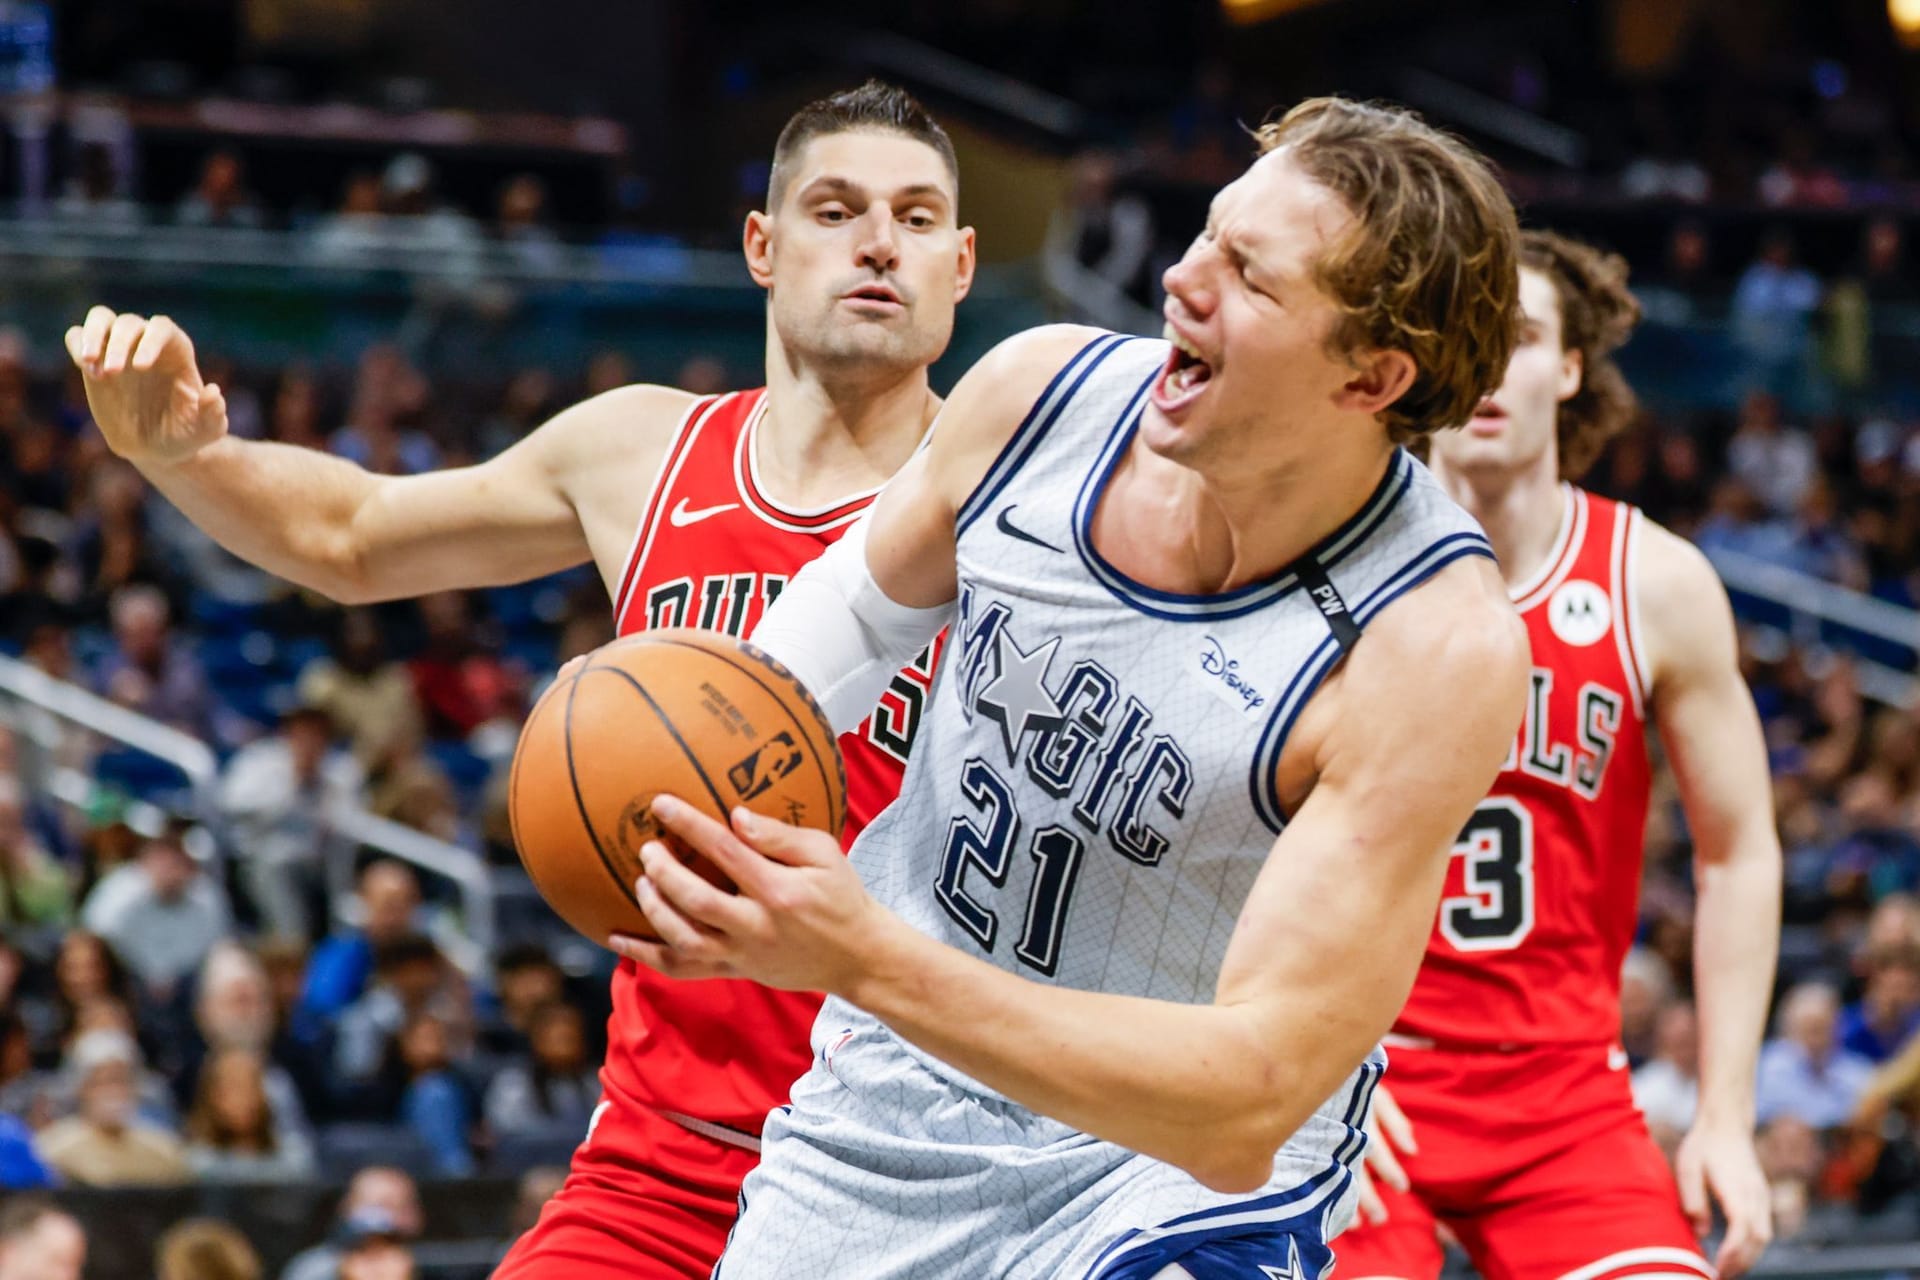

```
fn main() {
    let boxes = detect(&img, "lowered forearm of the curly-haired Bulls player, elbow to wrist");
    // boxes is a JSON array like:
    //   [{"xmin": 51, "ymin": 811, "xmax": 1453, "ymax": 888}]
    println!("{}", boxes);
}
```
[{"xmin": 1693, "ymin": 818, "xmax": 1780, "ymax": 1130}]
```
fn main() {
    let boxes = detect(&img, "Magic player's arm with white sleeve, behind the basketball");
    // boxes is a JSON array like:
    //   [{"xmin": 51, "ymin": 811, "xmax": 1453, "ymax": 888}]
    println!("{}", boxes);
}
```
[{"xmin": 751, "ymin": 324, "xmax": 1098, "ymax": 733}]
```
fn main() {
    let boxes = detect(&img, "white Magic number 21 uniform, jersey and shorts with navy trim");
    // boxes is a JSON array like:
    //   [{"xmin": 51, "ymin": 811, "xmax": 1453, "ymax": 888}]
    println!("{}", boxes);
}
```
[{"xmin": 720, "ymin": 336, "xmax": 1492, "ymax": 1280}]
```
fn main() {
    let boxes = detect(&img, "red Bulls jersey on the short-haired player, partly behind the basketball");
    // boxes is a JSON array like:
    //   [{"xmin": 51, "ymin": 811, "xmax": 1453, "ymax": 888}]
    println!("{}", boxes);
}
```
[{"xmin": 601, "ymin": 388, "xmax": 939, "ymax": 1134}]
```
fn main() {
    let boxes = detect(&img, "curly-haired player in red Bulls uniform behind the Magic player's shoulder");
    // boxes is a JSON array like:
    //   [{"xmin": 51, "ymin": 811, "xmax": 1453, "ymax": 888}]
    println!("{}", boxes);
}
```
[{"xmin": 1334, "ymin": 232, "xmax": 1780, "ymax": 1280}]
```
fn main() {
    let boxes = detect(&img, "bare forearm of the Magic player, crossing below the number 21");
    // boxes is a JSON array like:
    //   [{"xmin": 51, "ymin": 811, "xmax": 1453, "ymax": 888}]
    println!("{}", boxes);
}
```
[{"xmin": 839, "ymin": 917, "xmax": 1325, "ymax": 1192}]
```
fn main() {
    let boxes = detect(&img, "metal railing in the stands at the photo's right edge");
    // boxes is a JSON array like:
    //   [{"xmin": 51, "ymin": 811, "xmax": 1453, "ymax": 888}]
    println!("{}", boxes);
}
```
[{"xmin": 1707, "ymin": 551, "xmax": 1920, "ymax": 706}]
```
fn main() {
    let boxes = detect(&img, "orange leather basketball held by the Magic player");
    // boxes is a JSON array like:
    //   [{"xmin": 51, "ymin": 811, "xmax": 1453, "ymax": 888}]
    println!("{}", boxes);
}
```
[{"xmin": 507, "ymin": 628, "xmax": 847, "ymax": 942}]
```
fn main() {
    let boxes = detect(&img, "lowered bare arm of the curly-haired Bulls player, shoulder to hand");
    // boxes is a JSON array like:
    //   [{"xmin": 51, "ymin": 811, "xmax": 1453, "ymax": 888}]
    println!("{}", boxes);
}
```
[{"xmin": 1632, "ymin": 520, "xmax": 1782, "ymax": 1276}]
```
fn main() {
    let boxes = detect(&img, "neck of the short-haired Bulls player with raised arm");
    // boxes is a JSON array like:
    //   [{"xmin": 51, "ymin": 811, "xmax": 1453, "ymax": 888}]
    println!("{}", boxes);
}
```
[{"xmin": 755, "ymin": 359, "xmax": 941, "ymax": 507}]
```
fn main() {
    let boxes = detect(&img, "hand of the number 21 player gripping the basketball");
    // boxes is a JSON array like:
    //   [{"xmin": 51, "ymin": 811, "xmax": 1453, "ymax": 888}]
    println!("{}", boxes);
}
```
[{"xmin": 609, "ymin": 796, "xmax": 891, "ymax": 992}]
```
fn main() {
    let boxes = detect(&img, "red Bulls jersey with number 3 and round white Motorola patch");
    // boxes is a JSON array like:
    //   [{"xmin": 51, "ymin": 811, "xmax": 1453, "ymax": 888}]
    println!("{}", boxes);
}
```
[{"xmin": 1394, "ymin": 486, "xmax": 1651, "ymax": 1048}]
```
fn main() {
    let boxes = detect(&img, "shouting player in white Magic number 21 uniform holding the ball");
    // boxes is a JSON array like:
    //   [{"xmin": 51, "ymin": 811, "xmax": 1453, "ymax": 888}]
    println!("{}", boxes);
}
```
[{"xmin": 620, "ymin": 100, "xmax": 1526, "ymax": 1280}]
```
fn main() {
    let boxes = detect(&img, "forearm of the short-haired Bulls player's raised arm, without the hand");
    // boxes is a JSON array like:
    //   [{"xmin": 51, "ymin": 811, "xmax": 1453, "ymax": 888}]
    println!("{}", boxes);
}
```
[{"xmin": 140, "ymin": 436, "xmax": 378, "ymax": 601}]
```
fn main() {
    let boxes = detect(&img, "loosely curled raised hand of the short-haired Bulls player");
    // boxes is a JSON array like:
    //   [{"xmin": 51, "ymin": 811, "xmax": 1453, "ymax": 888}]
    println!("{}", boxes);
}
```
[{"xmin": 67, "ymin": 307, "xmax": 227, "ymax": 464}]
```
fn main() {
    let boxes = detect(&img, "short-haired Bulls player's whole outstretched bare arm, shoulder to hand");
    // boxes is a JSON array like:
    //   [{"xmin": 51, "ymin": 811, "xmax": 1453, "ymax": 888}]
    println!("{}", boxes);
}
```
[{"xmin": 67, "ymin": 307, "xmax": 689, "ymax": 603}]
